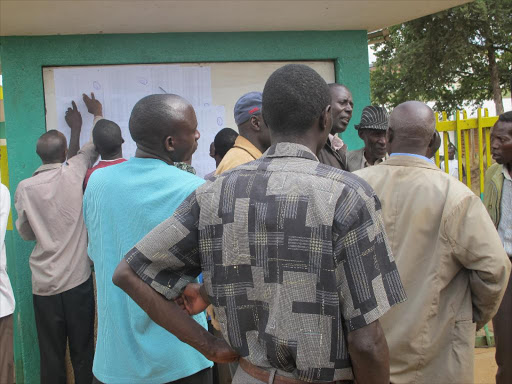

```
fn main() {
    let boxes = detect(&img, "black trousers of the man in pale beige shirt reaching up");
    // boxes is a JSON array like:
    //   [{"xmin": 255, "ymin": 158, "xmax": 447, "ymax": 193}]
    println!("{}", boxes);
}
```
[{"xmin": 33, "ymin": 276, "xmax": 94, "ymax": 384}]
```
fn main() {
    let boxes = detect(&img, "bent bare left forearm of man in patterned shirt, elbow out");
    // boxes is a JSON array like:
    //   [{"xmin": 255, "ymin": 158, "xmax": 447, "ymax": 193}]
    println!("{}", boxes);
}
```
[{"xmin": 112, "ymin": 259, "xmax": 238, "ymax": 363}]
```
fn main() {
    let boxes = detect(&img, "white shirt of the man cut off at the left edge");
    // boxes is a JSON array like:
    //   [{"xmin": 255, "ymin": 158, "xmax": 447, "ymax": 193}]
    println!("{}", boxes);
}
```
[{"xmin": 0, "ymin": 184, "xmax": 14, "ymax": 318}]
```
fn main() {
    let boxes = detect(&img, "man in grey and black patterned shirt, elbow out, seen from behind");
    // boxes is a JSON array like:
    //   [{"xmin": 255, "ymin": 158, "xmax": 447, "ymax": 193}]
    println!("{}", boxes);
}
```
[{"xmin": 113, "ymin": 64, "xmax": 405, "ymax": 384}]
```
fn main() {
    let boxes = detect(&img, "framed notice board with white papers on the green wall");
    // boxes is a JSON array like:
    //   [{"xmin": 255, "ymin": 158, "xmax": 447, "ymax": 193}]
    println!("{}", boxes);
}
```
[{"xmin": 43, "ymin": 61, "xmax": 335, "ymax": 177}]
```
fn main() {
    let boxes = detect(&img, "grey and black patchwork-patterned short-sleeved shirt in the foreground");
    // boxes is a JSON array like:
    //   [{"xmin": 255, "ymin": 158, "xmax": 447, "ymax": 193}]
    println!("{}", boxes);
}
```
[{"xmin": 126, "ymin": 143, "xmax": 405, "ymax": 382}]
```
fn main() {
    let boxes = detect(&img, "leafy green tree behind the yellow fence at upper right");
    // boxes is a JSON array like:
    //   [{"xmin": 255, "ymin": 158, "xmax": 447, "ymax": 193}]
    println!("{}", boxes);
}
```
[{"xmin": 371, "ymin": 0, "xmax": 512, "ymax": 114}]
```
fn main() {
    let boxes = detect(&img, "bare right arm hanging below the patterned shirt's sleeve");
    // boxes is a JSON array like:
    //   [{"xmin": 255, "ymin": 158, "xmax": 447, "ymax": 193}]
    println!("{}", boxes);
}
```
[{"xmin": 348, "ymin": 320, "xmax": 389, "ymax": 384}]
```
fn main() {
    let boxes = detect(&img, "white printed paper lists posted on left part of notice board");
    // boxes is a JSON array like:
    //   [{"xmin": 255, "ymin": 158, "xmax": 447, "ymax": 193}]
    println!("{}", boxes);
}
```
[{"xmin": 48, "ymin": 64, "xmax": 224, "ymax": 172}]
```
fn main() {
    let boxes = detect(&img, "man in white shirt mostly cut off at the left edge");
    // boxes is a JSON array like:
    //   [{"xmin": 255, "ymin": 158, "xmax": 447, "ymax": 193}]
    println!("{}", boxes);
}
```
[{"xmin": 0, "ymin": 184, "xmax": 14, "ymax": 384}]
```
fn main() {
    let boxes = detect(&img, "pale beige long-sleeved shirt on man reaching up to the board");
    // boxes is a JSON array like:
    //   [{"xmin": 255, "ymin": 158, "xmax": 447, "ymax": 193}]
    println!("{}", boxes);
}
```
[{"xmin": 14, "ymin": 143, "xmax": 98, "ymax": 296}]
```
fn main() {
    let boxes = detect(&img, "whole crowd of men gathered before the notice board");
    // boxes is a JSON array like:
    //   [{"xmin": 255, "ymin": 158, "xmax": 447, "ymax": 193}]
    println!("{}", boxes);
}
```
[{"xmin": 0, "ymin": 64, "xmax": 512, "ymax": 384}]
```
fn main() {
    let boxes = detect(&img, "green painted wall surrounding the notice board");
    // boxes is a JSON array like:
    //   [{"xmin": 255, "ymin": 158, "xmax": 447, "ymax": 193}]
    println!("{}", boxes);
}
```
[{"xmin": 0, "ymin": 31, "xmax": 370, "ymax": 383}]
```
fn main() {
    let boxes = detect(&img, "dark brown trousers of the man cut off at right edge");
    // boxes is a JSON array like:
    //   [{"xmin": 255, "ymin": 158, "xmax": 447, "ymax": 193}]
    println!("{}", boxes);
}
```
[{"xmin": 492, "ymin": 270, "xmax": 512, "ymax": 384}]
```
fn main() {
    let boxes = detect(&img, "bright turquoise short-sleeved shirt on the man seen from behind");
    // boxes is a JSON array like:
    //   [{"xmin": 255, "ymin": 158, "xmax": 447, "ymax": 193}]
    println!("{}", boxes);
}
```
[{"xmin": 84, "ymin": 157, "xmax": 213, "ymax": 384}]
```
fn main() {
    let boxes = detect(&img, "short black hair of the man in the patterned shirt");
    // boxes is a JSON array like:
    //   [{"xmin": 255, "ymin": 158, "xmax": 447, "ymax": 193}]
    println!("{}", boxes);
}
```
[{"xmin": 262, "ymin": 64, "xmax": 331, "ymax": 133}]
